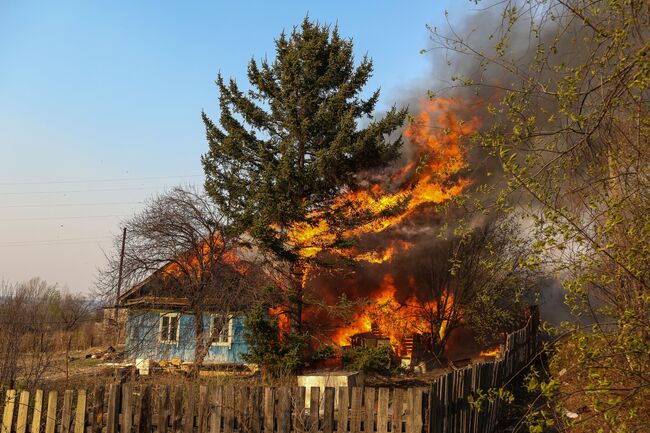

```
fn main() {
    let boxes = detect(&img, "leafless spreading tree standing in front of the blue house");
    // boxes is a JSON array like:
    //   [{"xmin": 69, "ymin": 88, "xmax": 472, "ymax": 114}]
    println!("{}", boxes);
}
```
[{"xmin": 99, "ymin": 188, "xmax": 259, "ymax": 372}]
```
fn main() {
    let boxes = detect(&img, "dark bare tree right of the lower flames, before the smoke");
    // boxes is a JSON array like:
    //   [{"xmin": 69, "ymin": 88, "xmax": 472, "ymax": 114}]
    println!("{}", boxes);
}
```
[{"xmin": 415, "ymin": 217, "xmax": 538, "ymax": 357}]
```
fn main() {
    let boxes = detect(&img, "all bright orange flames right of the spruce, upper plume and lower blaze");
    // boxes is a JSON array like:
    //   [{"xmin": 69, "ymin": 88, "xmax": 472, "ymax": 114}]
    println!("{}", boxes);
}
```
[{"xmin": 280, "ymin": 99, "xmax": 479, "ymax": 356}]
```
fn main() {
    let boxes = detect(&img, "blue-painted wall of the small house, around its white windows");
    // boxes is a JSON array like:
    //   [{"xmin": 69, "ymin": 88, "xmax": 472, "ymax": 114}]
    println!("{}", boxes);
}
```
[{"xmin": 125, "ymin": 310, "xmax": 248, "ymax": 364}]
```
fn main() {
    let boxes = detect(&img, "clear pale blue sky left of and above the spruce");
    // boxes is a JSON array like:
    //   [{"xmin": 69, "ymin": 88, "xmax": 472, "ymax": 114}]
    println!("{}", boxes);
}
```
[{"xmin": 0, "ymin": 0, "xmax": 473, "ymax": 293}]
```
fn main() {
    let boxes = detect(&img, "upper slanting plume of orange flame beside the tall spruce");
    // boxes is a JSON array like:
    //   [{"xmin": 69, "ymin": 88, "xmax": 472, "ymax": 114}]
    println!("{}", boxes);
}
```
[{"xmin": 288, "ymin": 99, "xmax": 479, "ymax": 263}]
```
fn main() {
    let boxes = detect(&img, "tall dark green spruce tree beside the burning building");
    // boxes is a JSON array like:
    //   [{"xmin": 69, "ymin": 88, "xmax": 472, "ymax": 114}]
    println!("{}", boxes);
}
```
[{"xmin": 202, "ymin": 18, "xmax": 406, "ymax": 325}]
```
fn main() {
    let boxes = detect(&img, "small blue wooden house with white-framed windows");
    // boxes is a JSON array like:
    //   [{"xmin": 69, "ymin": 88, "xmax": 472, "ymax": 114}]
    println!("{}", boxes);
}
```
[{"xmin": 119, "ymin": 272, "xmax": 248, "ymax": 365}]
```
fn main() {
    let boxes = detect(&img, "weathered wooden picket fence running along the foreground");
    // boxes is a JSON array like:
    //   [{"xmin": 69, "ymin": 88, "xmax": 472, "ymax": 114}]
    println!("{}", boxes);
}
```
[{"xmin": 0, "ymin": 308, "xmax": 537, "ymax": 433}]
